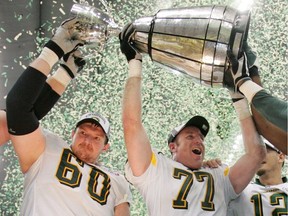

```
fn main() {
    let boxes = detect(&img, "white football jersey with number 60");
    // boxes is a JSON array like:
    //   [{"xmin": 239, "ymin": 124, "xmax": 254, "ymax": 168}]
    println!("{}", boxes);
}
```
[{"xmin": 21, "ymin": 131, "xmax": 132, "ymax": 216}]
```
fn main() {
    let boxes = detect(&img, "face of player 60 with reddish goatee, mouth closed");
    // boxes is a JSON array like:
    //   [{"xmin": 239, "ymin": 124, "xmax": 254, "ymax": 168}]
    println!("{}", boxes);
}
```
[{"xmin": 71, "ymin": 123, "xmax": 109, "ymax": 164}]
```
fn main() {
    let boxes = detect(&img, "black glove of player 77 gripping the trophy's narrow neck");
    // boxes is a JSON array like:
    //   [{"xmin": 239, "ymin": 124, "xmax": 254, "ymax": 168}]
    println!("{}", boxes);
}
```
[{"xmin": 119, "ymin": 23, "xmax": 142, "ymax": 62}]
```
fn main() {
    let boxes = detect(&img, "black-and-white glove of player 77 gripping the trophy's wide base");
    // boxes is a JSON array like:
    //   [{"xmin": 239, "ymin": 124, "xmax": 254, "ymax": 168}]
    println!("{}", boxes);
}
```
[{"xmin": 227, "ymin": 49, "xmax": 250, "ymax": 92}]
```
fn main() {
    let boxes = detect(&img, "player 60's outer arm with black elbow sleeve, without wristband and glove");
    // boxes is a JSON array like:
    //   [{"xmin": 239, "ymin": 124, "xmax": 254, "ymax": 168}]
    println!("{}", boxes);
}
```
[{"xmin": 6, "ymin": 58, "xmax": 50, "ymax": 173}]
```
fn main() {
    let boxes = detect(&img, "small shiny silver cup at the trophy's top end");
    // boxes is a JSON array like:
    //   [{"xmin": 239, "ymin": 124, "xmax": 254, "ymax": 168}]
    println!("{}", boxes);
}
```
[{"xmin": 70, "ymin": 4, "xmax": 121, "ymax": 50}]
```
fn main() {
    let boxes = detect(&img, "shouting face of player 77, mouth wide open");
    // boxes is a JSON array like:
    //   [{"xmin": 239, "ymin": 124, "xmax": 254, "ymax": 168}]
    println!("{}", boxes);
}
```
[{"xmin": 169, "ymin": 126, "xmax": 205, "ymax": 169}]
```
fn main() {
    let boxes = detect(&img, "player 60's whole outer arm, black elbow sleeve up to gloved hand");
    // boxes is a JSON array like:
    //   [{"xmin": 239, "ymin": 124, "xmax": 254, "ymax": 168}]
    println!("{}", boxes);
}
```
[{"xmin": 6, "ymin": 19, "xmax": 81, "ymax": 173}]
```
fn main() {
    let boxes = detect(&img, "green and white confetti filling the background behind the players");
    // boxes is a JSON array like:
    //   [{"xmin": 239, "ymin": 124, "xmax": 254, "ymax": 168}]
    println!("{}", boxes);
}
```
[{"xmin": 0, "ymin": 0, "xmax": 288, "ymax": 216}]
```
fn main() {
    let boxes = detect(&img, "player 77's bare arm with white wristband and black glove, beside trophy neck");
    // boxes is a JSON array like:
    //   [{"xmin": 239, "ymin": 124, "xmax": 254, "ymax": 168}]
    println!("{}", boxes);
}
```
[{"xmin": 120, "ymin": 24, "xmax": 152, "ymax": 176}]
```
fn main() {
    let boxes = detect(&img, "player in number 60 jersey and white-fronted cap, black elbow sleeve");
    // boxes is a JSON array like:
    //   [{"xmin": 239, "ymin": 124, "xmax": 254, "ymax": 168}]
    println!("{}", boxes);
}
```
[{"xmin": 6, "ymin": 18, "xmax": 131, "ymax": 216}]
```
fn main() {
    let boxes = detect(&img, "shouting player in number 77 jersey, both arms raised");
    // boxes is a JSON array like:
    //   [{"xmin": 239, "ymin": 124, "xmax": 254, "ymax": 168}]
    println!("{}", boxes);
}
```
[{"xmin": 119, "ymin": 24, "xmax": 266, "ymax": 216}]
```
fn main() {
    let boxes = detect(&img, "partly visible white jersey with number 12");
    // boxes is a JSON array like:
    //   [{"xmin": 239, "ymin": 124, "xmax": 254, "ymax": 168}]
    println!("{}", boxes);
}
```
[{"xmin": 227, "ymin": 178, "xmax": 288, "ymax": 216}]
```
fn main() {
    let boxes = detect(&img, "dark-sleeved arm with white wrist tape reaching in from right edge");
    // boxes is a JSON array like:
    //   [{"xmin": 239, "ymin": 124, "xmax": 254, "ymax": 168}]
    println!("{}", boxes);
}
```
[{"xmin": 238, "ymin": 41, "xmax": 288, "ymax": 155}]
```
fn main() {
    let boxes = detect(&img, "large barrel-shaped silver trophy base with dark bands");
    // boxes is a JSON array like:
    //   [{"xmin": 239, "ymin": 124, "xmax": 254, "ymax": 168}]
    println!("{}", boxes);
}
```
[{"xmin": 133, "ymin": 6, "xmax": 250, "ymax": 88}]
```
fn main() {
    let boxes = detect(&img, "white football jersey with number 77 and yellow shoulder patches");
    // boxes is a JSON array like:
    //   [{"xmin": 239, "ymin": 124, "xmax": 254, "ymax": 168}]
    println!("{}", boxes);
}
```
[{"xmin": 125, "ymin": 151, "xmax": 237, "ymax": 216}]
